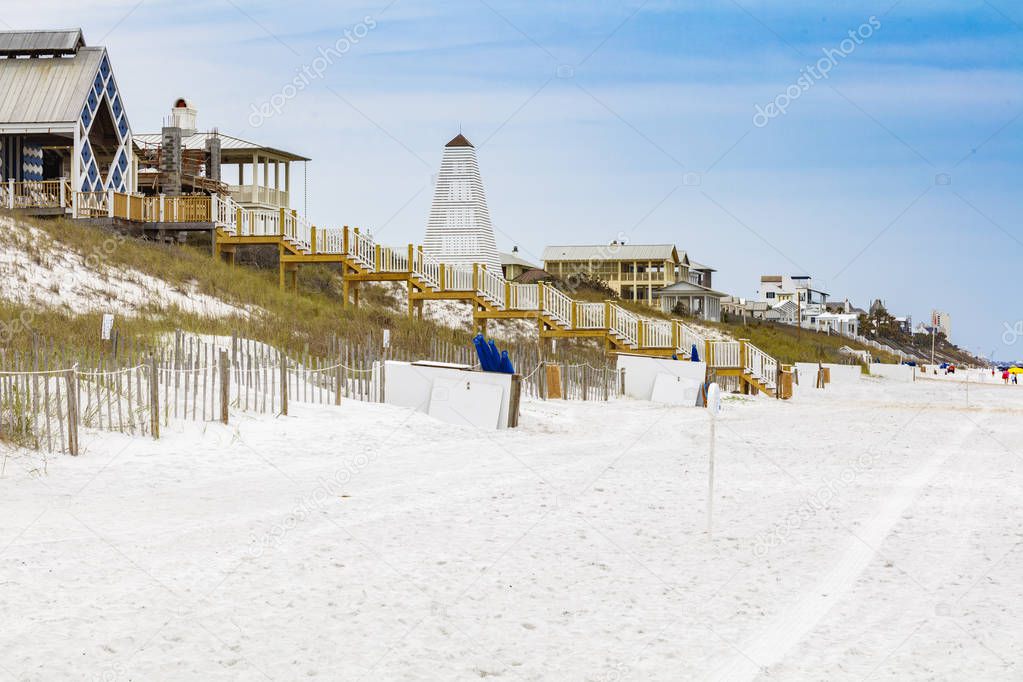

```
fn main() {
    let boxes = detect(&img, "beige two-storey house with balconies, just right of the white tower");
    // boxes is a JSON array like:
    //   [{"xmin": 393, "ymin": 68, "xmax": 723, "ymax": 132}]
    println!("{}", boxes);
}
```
[{"xmin": 543, "ymin": 241, "xmax": 690, "ymax": 306}]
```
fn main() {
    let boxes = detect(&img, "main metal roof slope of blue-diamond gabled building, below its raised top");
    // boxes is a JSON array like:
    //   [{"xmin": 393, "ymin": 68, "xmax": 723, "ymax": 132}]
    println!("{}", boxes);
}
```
[{"xmin": 0, "ymin": 47, "xmax": 106, "ymax": 125}]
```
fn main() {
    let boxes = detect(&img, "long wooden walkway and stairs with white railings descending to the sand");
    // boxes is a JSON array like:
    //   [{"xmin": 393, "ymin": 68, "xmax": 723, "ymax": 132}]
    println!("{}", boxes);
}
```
[{"xmin": 0, "ymin": 182, "xmax": 788, "ymax": 398}]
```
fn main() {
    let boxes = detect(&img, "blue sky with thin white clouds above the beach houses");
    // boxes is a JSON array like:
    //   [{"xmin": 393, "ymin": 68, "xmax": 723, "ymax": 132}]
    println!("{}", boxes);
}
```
[{"xmin": 9, "ymin": 0, "xmax": 1023, "ymax": 358}]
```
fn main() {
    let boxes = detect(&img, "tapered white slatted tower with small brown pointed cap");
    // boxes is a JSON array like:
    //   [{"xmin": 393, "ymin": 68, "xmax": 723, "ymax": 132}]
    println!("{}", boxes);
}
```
[{"xmin": 422, "ymin": 133, "xmax": 501, "ymax": 275}]
